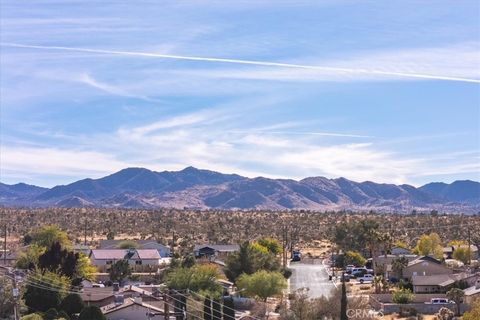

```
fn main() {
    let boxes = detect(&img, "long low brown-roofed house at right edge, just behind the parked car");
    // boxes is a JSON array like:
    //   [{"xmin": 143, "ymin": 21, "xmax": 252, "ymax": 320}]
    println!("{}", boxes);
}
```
[{"xmin": 412, "ymin": 273, "xmax": 478, "ymax": 293}]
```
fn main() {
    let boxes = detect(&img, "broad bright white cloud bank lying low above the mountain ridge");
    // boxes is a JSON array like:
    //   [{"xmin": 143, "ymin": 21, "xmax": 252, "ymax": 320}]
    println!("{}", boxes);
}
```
[{"xmin": 1, "ymin": 109, "xmax": 480, "ymax": 183}]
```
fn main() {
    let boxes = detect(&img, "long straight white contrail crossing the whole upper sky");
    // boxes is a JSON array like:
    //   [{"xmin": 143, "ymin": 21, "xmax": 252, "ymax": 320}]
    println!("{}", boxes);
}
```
[{"xmin": 0, "ymin": 43, "xmax": 480, "ymax": 83}]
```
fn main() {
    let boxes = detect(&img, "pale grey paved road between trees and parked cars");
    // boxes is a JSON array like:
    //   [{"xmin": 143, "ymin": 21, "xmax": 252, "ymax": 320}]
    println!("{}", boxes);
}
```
[{"xmin": 289, "ymin": 260, "xmax": 335, "ymax": 298}]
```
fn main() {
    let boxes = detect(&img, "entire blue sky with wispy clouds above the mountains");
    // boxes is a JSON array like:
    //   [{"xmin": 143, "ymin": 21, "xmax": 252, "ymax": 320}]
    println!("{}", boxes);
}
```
[{"xmin": 0, "ymin": 0, "xmax": 480, "ymax": 186}]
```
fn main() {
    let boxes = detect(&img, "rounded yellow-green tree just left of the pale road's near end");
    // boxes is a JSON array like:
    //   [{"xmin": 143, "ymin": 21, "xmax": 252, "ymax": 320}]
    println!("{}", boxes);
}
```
[{"xmin": 237, "ymin": 270, "xmax": 287, "ymax": 302}]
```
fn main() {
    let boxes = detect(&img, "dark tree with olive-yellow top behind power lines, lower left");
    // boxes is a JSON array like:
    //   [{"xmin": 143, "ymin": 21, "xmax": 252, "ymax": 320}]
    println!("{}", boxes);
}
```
[{"xmin": 23, "ymin": 271, "xmax": 71, "ymax": 312}]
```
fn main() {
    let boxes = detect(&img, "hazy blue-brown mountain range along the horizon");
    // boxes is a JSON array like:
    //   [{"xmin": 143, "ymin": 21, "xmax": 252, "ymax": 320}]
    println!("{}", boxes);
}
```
[{"xmin": 0, "ymin": 167, "xmax": 480, "ymax": 213}]
